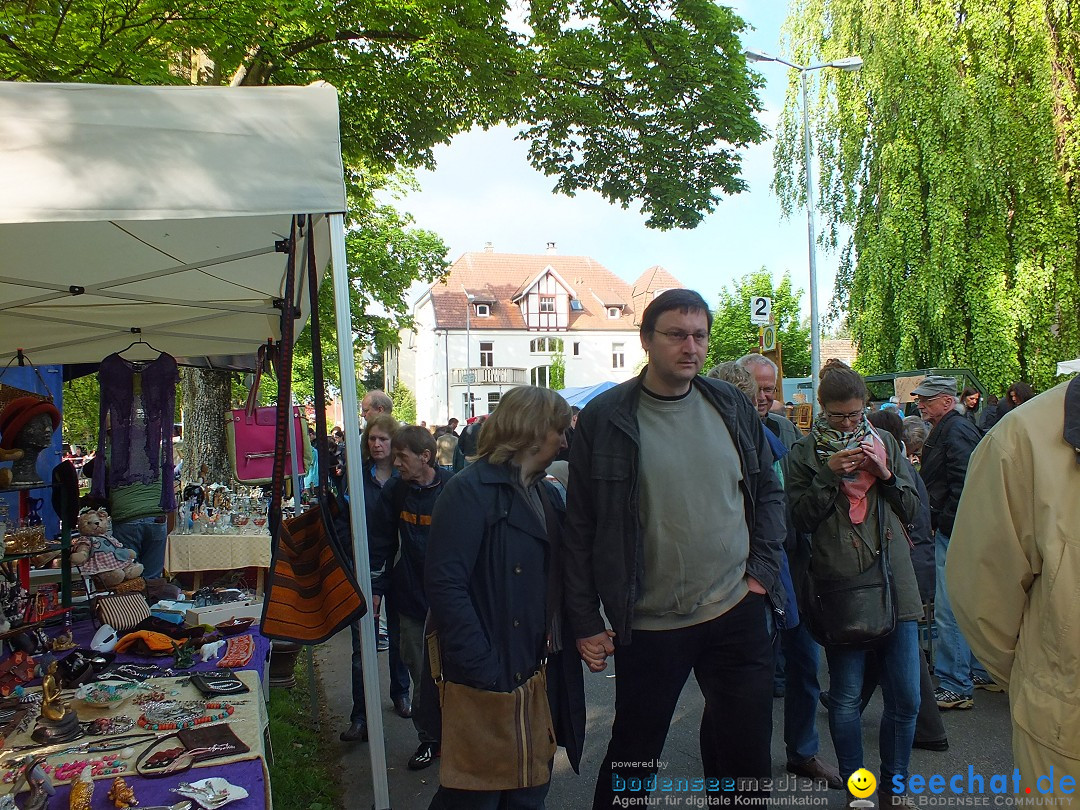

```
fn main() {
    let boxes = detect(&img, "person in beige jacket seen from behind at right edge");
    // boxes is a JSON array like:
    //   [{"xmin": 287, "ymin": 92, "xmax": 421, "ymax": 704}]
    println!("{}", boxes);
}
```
[{"xmin": 945, "ymin": 378, "xmax": 1080, "ymax": 796}]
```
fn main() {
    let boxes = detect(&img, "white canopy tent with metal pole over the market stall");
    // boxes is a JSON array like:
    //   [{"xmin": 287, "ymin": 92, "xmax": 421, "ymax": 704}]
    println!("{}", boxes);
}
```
[{"xmin": 0, "ymin": 82, "xmax": 390, "ymax": 808}]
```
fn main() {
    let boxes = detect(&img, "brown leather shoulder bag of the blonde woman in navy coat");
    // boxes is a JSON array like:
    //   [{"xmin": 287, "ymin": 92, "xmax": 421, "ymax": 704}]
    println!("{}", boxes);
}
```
[{"xmin": 428, "ymin": 632, "xmax": 556, "ymax": 791}]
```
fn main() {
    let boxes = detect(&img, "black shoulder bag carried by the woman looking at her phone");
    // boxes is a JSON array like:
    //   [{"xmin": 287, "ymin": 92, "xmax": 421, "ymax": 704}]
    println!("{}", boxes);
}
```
[{"xmin": 799, "ymin": 497, "xmax": 896, "ymax": 648}]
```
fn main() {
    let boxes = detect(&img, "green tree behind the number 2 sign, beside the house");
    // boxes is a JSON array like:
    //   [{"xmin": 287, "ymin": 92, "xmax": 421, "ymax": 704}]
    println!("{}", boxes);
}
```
[{"xmin": 705, "ymin": 267, "xmax": 810, "ymax": 377}]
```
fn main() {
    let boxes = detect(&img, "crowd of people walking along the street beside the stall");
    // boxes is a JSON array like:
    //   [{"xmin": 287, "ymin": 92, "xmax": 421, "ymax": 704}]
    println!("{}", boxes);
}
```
[{"xmin": 319, "ymin": 289, "xmax": 1080, "ymax": 808}]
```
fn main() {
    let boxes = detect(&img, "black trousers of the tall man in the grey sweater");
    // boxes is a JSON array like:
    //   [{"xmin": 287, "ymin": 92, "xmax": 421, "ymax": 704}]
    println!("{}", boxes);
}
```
[{"xmin": 593, "ymin": 593, "xmax": 773, "ymax": 810}]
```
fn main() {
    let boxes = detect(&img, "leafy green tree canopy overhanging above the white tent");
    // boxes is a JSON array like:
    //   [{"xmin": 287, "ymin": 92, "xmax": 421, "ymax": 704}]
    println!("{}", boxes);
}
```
[{"xmin": 6, "ymin": 0, "xmax": 762, "ymax": 228}]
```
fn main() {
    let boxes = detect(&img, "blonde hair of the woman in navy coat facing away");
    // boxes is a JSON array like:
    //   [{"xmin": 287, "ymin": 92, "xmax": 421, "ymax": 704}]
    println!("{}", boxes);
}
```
[{"xmin": 476, "ymin": 386, "xmax": 570, "ymax": 464}]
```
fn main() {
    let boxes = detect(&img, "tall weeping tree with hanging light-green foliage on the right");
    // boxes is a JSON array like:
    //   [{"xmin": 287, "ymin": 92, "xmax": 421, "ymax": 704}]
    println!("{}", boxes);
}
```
[{"xmin": 775, "ymin": 0, "xmax": 1080, "ymax": 390}]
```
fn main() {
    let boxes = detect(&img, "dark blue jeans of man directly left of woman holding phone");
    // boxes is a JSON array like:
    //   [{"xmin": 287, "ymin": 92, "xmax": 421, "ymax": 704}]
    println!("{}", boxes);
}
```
[{"xmin": 780, "ymin": 621, "xmax": 821, "ymax": 765}]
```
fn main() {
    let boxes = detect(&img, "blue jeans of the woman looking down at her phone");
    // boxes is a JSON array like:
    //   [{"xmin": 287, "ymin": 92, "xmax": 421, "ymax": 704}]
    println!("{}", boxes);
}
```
[{"xmin": 825, "ymin": 621, "xmax": 922, "ymax": 785}]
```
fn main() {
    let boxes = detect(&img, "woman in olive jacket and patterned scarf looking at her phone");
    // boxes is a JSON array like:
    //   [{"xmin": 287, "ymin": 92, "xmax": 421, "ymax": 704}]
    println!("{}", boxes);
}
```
[{"xmin": 786, "ymin": 360, "xmax": 922, "ymax": 807}]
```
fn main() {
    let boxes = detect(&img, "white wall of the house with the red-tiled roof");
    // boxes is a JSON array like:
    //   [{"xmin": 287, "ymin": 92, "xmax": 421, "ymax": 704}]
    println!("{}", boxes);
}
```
[{"xmin": 399, "ymin": 300, "xmax": 645, "ymax": 424}]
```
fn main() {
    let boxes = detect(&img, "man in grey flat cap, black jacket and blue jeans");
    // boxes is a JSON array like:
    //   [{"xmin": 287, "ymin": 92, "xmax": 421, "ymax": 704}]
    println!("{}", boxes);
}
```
[{"xmin": 912, "ymin": 375, "xmax": 996, "ymax": 710}]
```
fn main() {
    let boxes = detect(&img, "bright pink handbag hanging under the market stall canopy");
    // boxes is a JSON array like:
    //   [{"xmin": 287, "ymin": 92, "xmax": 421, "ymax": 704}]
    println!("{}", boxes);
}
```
[{"xmin": 225, "ymin": 354, "xmax": 311, "ymax": 484}]
